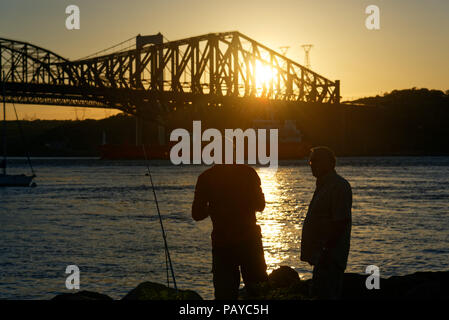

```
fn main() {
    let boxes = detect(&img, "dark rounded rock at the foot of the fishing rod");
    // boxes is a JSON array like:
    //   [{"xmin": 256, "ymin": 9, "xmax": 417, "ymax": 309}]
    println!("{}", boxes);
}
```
[{"xmin": 122, "ymin": 281, "xmax": 203, "ymax": 300}]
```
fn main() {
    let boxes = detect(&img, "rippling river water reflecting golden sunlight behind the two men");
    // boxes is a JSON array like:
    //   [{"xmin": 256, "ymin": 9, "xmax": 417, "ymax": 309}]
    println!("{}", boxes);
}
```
[{"xmin": 0, "ymin": 157, "xmax": 449, "ymax": 299}]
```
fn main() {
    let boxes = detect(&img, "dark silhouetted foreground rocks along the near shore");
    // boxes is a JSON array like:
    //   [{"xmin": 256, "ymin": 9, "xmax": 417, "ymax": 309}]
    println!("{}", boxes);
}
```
[{"xmin": 52, "ymin": 266, "xmax": 449, "ymax": 301}]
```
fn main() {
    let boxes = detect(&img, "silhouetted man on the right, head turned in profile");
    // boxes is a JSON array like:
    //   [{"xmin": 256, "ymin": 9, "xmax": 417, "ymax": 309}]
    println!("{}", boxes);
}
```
[{"xmin": 301, "ymin": 147, "xmax": 352, "ymax": 299}]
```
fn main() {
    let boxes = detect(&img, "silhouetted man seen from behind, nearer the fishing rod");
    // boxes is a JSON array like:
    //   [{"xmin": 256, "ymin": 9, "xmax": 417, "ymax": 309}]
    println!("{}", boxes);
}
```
[{"xmin": 192, "ymin": 164, "xmax": 267, "ymax": 300}]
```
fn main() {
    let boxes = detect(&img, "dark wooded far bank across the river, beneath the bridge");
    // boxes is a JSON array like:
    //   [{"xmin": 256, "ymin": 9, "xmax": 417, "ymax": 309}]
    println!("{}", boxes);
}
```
[{"xmin": 6, "ymin": 88, "xmax": 449, "ymax": 158}]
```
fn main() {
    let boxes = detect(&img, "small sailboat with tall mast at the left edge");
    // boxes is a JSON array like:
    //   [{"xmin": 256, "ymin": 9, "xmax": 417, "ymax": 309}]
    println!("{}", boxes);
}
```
[{"xmin": 0, "ymin": 72, "xmax": 36, "ymax": 187}]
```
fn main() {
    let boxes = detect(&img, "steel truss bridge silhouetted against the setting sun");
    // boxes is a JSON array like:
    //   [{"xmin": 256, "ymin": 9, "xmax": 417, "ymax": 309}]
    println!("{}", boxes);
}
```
[{"xmin": 0, "ymin": 32, "xmax": 340, "ymax": 116}]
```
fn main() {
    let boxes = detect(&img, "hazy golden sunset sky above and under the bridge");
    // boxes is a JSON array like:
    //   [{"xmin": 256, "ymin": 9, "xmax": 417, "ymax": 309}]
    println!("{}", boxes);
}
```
[{"xmin": 0, "ymin": 0, "xmax": 449, "ymax": 119}]
